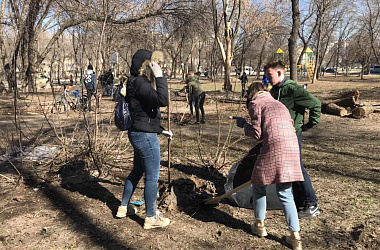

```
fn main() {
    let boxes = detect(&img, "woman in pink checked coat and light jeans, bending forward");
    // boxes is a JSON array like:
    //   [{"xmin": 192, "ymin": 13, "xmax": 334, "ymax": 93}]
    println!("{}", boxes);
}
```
[{"xmin": 236, "ymin": 82, "xmax": 303, "ymax": 250}]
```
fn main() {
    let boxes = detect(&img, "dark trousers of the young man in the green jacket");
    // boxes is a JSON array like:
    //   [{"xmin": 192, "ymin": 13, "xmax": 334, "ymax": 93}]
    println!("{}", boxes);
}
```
[{"xmin": 292, "ymin": 133, "xmax": 317, "ymax": 208}]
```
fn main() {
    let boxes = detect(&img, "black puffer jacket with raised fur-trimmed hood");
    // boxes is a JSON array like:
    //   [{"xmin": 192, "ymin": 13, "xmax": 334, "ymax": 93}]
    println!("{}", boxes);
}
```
[{"xmin": 126, "ymin": 50, "xmax": 168, "ymax": 133}]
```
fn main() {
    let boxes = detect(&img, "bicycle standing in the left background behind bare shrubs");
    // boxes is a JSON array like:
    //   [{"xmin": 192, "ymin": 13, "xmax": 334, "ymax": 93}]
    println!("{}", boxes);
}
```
[{"xmin": 51, "ymin": 89, "xmax": 87, "ymax": 114}]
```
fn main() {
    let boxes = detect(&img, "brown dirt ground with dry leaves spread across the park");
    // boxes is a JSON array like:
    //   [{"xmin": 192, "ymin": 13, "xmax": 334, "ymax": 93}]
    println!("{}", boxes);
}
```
[{"xmin": 0, "ymin": 76, "xmax": 380, "ymax": 249}]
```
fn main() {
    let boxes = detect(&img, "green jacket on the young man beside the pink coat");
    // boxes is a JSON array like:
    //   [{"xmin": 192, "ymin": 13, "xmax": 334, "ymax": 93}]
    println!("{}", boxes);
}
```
[{"xmin": 270, "ymin": 79, "xmax": 321, "ymax": 135}]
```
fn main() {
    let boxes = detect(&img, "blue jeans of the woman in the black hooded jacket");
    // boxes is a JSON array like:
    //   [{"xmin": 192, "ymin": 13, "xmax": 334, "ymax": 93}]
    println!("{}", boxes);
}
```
[{"xmin": 121, "ymin": 131, "xmax": 160, "ymax": 217}]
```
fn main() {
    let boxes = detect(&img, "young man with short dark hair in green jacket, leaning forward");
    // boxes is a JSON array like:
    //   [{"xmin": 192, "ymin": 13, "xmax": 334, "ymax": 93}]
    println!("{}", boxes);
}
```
[{"xmin": 265, "ymin": 61, "xmax": 321, "ymax": 218}]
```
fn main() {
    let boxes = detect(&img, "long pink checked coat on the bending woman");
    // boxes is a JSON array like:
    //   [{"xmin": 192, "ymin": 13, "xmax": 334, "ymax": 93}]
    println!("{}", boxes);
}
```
[{"xmin": 244, "ymin": 92, "xmax": 304, "ymax": 185}]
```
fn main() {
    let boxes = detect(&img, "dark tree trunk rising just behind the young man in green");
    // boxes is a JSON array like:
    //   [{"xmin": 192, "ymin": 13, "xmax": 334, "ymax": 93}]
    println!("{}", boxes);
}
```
[{"xmin": 288, "ymin": 0, "xmax": 301, "ymax": 81}]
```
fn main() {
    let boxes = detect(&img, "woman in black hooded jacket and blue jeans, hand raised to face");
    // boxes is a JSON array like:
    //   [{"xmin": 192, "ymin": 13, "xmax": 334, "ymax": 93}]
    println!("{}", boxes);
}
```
[{"xmin": 116, "ymin": 50, "xmax": 170, "ymax": 229}]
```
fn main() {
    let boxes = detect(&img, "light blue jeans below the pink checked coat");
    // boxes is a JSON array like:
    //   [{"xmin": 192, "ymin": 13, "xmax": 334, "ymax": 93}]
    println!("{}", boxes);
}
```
[{"xmin": 252, "ymin": 183, "xmax": 300, "ymax": 232}]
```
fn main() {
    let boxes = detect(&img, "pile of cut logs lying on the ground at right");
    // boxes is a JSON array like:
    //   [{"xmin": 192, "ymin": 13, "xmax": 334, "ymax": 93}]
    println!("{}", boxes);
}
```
[{"xmin": 322, "ymin": 91, "xmax": 380, "ymax": 119}]
